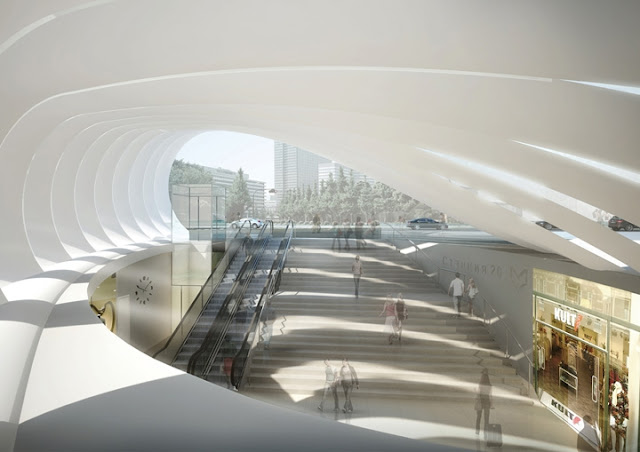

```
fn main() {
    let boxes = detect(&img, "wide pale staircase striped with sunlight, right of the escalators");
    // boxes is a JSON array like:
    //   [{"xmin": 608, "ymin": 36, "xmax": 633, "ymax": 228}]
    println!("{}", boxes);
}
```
[{"xmin": 245, "ymin": 239, "xmax": 532, "ymax": 404}]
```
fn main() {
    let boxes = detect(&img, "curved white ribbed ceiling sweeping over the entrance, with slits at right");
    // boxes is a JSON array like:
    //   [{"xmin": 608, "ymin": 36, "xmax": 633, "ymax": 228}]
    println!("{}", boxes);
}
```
[{"xmin": 0, "ymin": 0, "xmax": 640, "ymax": 286}]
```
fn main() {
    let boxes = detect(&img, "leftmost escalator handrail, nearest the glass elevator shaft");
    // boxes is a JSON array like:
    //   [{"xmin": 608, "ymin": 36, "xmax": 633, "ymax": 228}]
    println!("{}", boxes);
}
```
[{"xmin": 152, "ymin": 228, "xmax": 248, "ymax": 362}]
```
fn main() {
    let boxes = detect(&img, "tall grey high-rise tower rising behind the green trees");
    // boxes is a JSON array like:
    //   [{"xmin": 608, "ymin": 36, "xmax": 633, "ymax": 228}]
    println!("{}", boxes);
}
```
[{"xmin": 274, "ymin": 141, "xmax": 331, "ymax": 202}]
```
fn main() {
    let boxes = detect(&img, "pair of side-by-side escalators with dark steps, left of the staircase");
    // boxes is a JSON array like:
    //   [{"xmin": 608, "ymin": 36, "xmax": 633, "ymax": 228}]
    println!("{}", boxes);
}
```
[{"xmin": 154, "ymin": 222, "xmax": 293, "ymax": 389}]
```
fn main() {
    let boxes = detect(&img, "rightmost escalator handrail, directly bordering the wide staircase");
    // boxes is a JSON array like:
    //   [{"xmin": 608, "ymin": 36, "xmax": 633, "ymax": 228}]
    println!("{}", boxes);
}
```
[{"xmin": 231, "ymin": 220, "xmax": 295, "ymax": 390}]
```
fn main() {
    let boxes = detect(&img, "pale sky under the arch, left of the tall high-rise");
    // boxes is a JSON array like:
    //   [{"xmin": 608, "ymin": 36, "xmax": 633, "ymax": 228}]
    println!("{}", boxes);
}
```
[{"xmin": 176, "ymin": 131, "xmax": 274, "ymax": 189}]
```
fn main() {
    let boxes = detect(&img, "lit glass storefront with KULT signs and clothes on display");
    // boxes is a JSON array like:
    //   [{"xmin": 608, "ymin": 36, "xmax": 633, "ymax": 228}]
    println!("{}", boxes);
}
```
[{"xmin": 533, "ymin": 269, "xmax": 640, "ymax": 452}]
